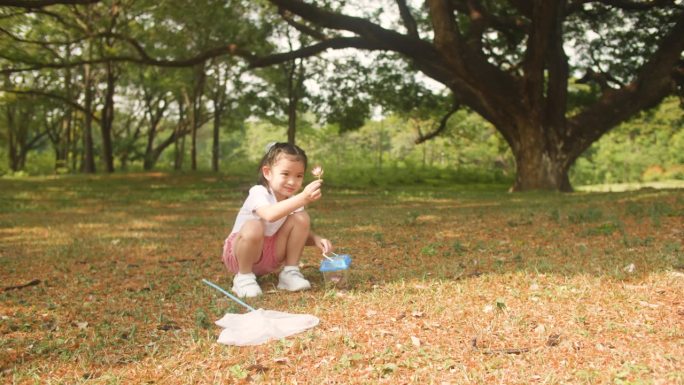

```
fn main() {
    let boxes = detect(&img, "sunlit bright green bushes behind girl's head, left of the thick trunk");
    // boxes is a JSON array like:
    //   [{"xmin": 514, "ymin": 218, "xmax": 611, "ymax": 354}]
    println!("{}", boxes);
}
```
[{"xmin": 224, "ymin": 111, "xmax": 510, "ymax": 187}]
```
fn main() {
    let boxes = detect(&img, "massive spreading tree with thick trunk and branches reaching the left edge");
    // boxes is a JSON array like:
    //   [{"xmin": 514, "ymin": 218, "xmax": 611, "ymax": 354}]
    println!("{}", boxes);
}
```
[{"xmin": 0, "ymin": 0, "xmax": 684, "ymax": 186}]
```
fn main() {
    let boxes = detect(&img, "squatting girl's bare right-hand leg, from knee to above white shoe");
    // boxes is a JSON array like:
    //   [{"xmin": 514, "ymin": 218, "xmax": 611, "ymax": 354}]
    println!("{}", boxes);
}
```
[{"xmin": 275, "ymin": 211, "xmax": 311, "ymax": 266}]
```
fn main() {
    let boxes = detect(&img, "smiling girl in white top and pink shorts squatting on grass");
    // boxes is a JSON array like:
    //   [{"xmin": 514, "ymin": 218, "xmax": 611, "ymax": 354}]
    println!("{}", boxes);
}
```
[{"xmin": 223, "ymin": 143, "xmax": 333, "ymax": 297}]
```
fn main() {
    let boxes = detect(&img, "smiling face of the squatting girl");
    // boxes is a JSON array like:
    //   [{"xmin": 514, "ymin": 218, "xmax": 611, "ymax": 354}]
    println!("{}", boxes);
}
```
[{"xmin": 261, "ymin": 154, "xmax": 306, "ymax": 201}]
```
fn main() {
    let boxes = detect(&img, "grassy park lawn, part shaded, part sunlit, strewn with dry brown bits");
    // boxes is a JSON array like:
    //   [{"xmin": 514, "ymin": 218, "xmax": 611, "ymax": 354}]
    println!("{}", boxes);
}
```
[{"xmin": 0, "ymin": 174, "xmax": 684, "ymax": 384}]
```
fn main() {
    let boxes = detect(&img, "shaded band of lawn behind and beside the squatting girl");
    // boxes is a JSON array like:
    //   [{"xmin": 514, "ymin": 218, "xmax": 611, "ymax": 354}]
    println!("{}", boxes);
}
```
[{"xmin": 0, "ymin": 173, "xmax": 684, "ymax": 289}]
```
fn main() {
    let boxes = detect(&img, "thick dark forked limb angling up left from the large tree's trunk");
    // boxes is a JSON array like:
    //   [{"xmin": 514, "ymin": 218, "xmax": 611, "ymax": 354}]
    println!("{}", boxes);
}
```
[{"xmin": 269, "ymin": 0, "xmax": 521, "ymax": 134}]
